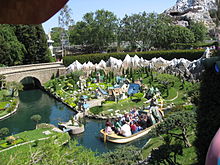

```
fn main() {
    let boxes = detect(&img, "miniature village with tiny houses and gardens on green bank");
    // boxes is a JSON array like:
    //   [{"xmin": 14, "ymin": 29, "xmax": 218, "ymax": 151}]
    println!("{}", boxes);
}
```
[{"xmin": 44, "ymin": 67, "xmax": 197, "ymax": 119}]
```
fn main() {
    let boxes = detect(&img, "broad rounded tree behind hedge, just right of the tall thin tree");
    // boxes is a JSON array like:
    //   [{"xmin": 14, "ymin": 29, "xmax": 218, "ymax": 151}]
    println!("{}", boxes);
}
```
[{"xmin": 70, "ymin": 9, "xmax": 118, "ymax": 51}]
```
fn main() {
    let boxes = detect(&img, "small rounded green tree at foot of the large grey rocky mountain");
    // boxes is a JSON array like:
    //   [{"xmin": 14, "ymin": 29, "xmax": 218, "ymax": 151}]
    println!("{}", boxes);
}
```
[{"xmin": 189, "ymin": 21, "xmax": 208, "ymax": 42}]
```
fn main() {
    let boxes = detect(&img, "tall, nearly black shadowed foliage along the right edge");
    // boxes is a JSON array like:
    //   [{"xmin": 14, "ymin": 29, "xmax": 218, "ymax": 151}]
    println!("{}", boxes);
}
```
[{"xmin": 196, "ymin": 67, "xmax": 220, "ymax": 164}]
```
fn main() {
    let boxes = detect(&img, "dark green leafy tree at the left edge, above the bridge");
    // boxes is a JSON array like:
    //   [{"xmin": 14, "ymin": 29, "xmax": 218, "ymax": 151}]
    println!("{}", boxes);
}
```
[{"xmin": 0, "ymin": 25, "xmax": 26, "ymax": 66}]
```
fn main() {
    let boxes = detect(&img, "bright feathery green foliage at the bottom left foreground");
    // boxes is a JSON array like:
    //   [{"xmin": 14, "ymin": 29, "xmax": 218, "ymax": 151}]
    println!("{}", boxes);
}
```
[{"xmin": 1, "ymin": 137, "xmax": 104, "ymax": 165}]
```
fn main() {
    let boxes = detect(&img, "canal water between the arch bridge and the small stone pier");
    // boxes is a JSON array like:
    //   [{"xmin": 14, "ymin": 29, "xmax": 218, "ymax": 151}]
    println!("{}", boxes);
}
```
[{"xmin": 0, "ymin": 89, "xmax": 75, "ymax": 134}]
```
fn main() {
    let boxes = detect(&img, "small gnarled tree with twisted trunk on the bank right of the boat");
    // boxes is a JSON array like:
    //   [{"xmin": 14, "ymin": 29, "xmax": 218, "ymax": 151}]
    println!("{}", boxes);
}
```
[{"xmin": 156, "ymin": 111, "xmax": 196, "ymax": 147}]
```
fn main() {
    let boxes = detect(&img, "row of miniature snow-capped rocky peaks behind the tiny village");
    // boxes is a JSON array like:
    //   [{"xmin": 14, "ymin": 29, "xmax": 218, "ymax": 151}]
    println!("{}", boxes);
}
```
[{"xmin": 67, "ymin": 54, "xmax": 205, "ymax": 81}]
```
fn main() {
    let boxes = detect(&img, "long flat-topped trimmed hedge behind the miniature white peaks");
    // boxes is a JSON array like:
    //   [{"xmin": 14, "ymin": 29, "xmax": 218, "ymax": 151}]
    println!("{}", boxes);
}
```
[{"xmin": 63, "ymin": 50, "xmax": 204, "ymax": 66}]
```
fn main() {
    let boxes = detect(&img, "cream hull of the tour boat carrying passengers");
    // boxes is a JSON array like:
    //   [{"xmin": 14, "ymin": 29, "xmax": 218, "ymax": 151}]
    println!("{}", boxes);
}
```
[{"xmin": 100, "ymin": 124, "xmax": 157, "ymax": 144}]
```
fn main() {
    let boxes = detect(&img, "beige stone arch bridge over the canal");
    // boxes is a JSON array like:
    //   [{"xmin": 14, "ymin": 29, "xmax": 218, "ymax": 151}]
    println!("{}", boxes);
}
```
[{"xmin": 0, "ymin": 62, "xmax": 66, "ymax": 84}]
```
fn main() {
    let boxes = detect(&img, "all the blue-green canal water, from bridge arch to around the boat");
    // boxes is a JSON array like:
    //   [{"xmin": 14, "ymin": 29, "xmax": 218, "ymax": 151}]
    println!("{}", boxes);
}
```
[{"xmin": 0, "ymin": 89, "xmax": 148, "ymax": 153}]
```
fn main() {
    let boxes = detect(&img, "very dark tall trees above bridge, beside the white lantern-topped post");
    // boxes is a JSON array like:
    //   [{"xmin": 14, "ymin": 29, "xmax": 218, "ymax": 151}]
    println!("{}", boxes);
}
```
[{"xmin": 15, "ymin": 25, "xmax": 51, "ymax": 64}]
